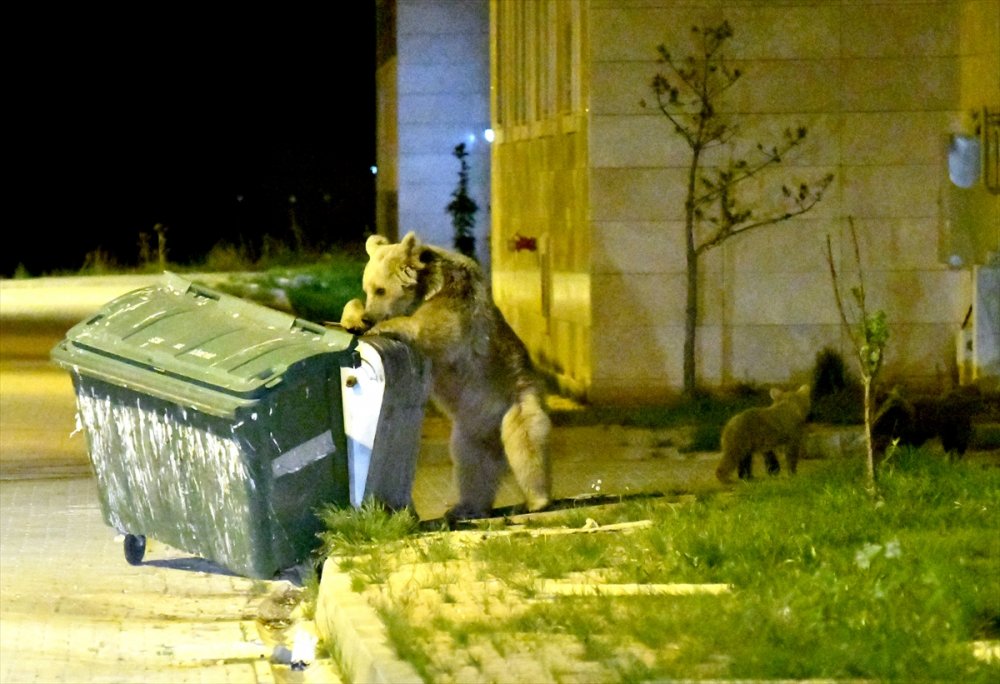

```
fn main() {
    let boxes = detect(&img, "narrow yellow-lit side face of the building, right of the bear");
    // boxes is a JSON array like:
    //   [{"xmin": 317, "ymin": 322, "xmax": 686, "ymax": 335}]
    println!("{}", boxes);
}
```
[{"xmin": 491, "ymin": 0, "xmax": 593, "ymax": 394}]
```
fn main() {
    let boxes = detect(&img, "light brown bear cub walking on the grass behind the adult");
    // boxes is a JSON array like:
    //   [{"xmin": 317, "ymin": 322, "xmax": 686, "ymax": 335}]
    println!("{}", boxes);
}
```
[{"xmin": 715, "ymin": 385, "xmax": 810, "ymax": 483}]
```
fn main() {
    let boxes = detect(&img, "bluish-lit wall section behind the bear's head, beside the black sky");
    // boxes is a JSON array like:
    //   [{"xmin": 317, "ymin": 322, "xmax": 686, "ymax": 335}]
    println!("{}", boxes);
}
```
[{"xmin": 379, "ymin": 0, "xmax": 491, "ymax": 263}]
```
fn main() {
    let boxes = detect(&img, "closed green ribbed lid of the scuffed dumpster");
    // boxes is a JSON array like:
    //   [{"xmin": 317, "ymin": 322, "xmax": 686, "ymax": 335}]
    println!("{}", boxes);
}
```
[{"xmin": 53, "ymin": 273, "xmax": 356, "ymax": 399}]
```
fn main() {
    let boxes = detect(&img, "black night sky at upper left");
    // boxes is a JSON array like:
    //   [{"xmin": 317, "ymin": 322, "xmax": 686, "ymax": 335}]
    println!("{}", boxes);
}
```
[{"xmin": 6, "ymin": 5, "xmax": 375, "ymax": 276}]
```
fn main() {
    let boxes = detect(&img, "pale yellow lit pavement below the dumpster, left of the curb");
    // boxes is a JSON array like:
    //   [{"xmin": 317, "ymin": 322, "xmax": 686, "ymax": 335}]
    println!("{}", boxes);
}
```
[{"xmin": 0, "ymin": 478, "xmax": 339, "ymax": 684}]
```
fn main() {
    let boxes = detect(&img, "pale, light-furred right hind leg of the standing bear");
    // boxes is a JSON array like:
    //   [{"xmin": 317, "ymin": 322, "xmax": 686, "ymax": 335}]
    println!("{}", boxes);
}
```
[{"xmin": 500, "ymin": 392, "xmax": 552, "ymax": 511}]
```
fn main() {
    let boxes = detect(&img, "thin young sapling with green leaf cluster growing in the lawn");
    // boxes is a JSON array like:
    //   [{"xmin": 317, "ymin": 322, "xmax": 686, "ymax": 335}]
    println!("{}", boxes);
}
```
[{"xmin": 826, "ymin": 218, "xmax": 889, "ymax": 493}]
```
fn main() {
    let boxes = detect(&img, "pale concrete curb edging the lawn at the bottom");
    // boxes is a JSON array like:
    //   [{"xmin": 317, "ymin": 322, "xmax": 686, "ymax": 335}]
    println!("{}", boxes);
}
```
[{"xmin": 316, "ymin": 558, "xmax": 424, "ymax": 684}]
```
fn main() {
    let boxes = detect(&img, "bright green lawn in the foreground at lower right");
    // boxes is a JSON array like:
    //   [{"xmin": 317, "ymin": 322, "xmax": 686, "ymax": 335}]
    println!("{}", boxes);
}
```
[{"xmin": 322, "ymin": 449, "xmax": 1000, "ymax": 682}]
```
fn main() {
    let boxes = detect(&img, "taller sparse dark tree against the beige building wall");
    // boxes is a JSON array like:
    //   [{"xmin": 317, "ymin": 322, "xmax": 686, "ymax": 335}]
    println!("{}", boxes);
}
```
[{"xmin": 641, "ymin": 21, "xmax": 833, "ymax": 394}]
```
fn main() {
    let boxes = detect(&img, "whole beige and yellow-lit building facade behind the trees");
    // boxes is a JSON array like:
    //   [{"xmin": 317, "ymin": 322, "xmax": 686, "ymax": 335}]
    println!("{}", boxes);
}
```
[{"xmin": 489, "ymin": 0, "xmax": 1000, "ymax": 402}]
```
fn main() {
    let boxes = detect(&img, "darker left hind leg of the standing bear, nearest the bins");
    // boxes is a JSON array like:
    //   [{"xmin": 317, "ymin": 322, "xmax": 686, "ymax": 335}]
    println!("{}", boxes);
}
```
[{"xmin": 445, "ymin": 420, "xmax": 507, "ymax": 520}]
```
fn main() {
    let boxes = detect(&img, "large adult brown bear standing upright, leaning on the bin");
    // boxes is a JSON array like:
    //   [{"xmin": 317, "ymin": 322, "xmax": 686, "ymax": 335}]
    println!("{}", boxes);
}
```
[{"xmin": 341, "ymin": 232, "xmax": 551, "ymax": 521}]
